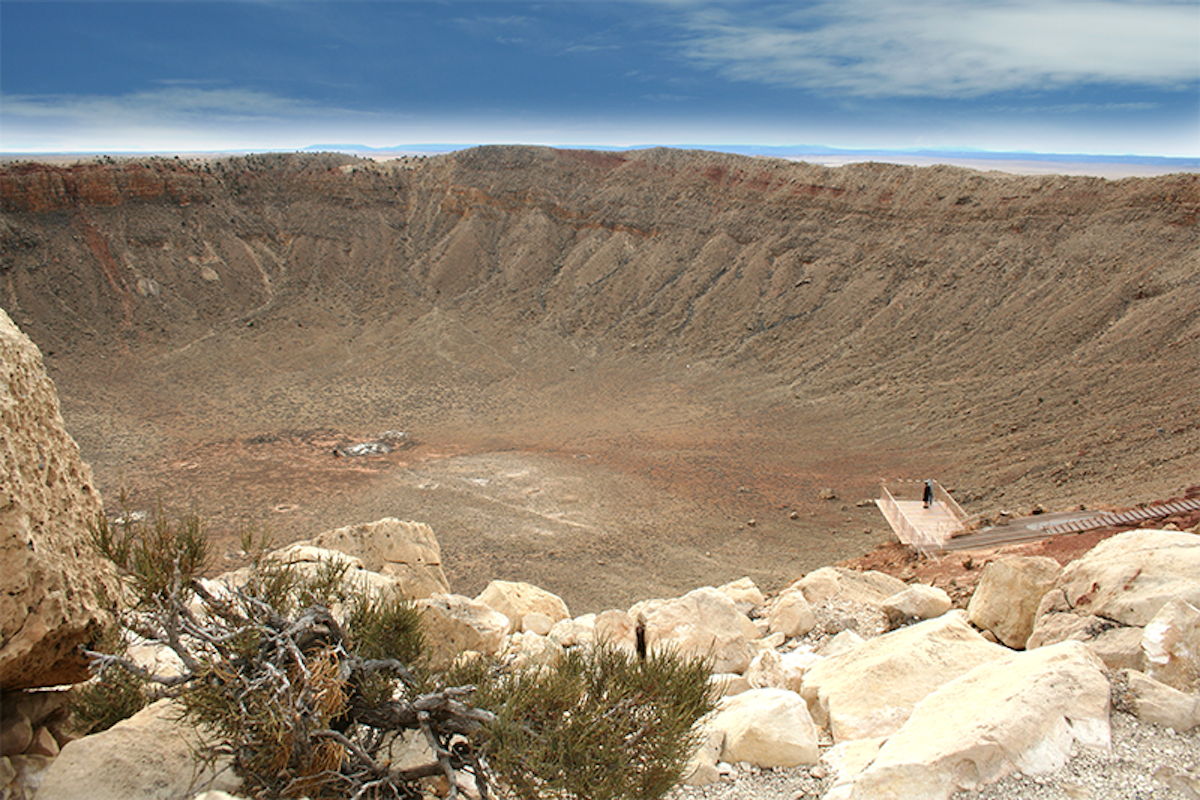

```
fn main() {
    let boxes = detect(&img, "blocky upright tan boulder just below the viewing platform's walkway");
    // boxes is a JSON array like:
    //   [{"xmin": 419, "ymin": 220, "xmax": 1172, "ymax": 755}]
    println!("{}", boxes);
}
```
[{"xmin": 967, "ymin": 555, "xmax": 1062, "ymax": 650}]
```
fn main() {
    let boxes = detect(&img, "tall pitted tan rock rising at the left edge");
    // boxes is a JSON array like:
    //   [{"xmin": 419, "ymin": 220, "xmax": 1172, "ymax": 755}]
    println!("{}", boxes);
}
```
[{"xmin": 0, "ymin": 309, "xmax": 119, "ymax": 692}]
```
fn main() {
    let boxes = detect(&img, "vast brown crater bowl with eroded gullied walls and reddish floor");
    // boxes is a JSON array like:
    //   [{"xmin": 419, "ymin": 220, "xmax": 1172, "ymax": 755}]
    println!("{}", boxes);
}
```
[{"xmin": 0, "ymin": 148, "xmax": 1200, "ymax": 612}]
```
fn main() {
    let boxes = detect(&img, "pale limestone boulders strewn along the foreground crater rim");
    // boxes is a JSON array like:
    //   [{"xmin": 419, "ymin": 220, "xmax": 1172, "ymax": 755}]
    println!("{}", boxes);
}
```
[{"xmin": 0, "ymin": 314, "xmax": 1200, "ymax": 800}]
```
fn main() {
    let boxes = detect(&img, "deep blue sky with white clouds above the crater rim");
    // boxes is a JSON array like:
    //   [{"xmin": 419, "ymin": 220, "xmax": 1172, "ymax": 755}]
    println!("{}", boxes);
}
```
[{"xmin": 0, "ymin": 0, "xmax": 1200, "ymax": 157}]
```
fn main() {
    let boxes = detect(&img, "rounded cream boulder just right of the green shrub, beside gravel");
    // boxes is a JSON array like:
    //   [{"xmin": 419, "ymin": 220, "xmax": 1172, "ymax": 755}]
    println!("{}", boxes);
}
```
[{"xmin": 707, "ymin": 688, "xmax": 820, "ymax": 768}]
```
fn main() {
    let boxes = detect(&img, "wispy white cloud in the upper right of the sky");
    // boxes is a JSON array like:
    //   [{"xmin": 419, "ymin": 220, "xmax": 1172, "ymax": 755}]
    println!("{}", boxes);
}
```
[{"xmin": 683, "ymin": 0, "xmax": 1200, "ymax": 98}]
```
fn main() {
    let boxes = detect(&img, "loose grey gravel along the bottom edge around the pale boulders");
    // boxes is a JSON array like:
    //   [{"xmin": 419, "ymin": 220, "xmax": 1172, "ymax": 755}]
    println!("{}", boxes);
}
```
[{"xmin": 667, "ymin": 711, "xmax": 1200, "ymax": 800}]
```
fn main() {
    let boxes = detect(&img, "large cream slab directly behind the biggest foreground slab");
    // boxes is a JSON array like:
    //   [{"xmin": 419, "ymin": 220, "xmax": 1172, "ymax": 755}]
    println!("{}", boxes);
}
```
[{"xmin": 800, "ymin": 612, "xmax": 1010, "ymax": 742}]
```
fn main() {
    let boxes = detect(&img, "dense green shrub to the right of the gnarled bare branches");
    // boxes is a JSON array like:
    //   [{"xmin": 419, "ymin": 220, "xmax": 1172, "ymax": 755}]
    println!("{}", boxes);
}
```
[{"xmin": 449, "ymin": 645, "xmax": 715, "ymax": 800}]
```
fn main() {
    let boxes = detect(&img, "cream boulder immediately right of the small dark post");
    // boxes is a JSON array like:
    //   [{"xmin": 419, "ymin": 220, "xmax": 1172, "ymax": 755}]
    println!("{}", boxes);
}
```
[{"xmin": 629, "ymin": 587, "xmax": 757, "ymax": 673}]
